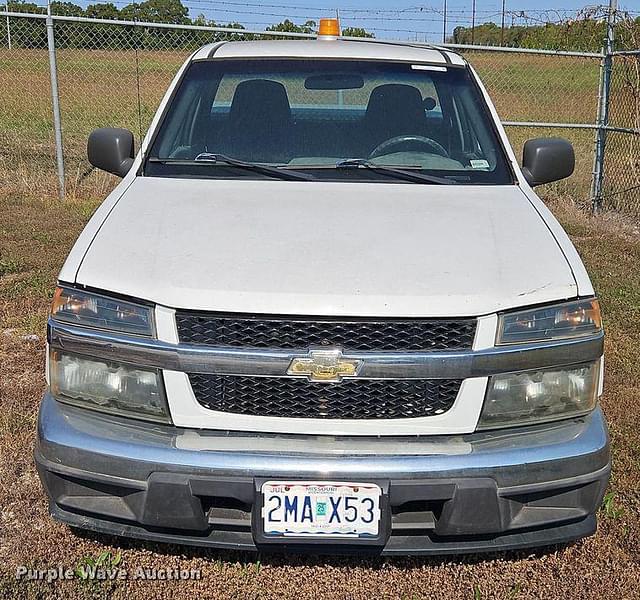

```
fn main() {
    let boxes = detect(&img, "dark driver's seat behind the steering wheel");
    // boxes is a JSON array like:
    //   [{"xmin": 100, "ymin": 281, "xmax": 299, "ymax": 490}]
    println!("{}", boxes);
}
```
[{"xmin": 364, "ymin": 83, "xmax": 426, "ymax": 151}]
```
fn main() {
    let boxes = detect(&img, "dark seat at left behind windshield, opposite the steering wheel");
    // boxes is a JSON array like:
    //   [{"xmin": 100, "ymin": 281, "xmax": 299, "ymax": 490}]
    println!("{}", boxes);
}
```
[{"xmin": 218, "ymin": 79, "xmax": 293, "ymax": 162}]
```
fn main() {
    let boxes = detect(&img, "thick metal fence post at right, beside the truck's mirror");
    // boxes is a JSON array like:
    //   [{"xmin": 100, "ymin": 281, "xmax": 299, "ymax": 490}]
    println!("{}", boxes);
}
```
[{"xmin": 591, "ymin": 0, "xmax": 618, "ymax": 213}]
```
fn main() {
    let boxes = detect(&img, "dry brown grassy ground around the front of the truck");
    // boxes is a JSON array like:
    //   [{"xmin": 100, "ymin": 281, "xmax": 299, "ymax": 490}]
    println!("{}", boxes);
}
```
[{"xmin": 0, "ymin": 194, "xmax": 640, "ymax": 600}]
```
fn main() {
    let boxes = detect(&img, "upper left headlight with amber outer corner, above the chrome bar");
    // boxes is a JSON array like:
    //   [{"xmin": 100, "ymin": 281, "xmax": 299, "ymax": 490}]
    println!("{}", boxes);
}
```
[{"xmin": 51, "ymin": 287, "xmax": 154, "ymax": 336}]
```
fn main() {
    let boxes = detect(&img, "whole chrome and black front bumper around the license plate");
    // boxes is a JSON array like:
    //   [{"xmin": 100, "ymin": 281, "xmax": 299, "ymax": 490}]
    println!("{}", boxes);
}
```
[{"xmin": 35, "ymin": 395, "xmax": 610, "ymax": 554}]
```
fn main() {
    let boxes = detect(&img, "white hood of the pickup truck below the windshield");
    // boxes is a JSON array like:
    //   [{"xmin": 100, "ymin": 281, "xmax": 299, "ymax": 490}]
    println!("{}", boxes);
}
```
[{"xmin": 72, "ymin": 178, "xmax": 577, "ymax": 317}]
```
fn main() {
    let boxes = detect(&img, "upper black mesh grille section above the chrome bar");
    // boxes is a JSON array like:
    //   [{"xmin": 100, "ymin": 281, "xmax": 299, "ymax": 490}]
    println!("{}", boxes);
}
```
[{"xmin": 176, "ymin": 311, "xmax": 476, "ymax": 351}]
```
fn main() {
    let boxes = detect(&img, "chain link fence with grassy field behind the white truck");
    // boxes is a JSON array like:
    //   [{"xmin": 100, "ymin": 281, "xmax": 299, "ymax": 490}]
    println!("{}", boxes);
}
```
[{"xmin": 0, "ymin": 12, "xmax": 640, "ymax": 213}]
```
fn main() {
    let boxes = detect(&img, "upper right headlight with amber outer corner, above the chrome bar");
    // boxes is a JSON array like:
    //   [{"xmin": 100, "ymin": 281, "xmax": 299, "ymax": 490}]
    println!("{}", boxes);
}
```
[{"xmin": 496, "ymin": 298, "xmax": 602, "ymax": 345}]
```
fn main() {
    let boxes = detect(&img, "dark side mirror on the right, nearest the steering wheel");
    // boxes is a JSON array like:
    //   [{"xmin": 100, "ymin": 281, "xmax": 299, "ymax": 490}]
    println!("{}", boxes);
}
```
[{"xmin": 522, "ymin": 138, "xmax": 576, "ymax": 186}]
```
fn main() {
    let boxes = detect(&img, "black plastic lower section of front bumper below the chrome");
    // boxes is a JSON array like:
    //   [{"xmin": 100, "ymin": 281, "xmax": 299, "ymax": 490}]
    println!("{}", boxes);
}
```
[{"xmin": 36, "ymin": 453, "xmax": 609, "ymax": 554}]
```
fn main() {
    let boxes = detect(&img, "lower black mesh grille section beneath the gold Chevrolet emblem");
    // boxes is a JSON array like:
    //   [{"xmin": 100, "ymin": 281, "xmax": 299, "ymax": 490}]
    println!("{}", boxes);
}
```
[{"xmin": 189, "ymin": 374, "xmax": 462, "ymax": 419}]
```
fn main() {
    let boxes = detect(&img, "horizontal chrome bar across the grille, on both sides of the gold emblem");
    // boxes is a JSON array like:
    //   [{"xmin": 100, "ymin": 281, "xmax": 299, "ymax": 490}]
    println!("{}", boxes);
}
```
[{"xmin": 48, "ymin": 319, "xmax": 604, "ymax": 379}]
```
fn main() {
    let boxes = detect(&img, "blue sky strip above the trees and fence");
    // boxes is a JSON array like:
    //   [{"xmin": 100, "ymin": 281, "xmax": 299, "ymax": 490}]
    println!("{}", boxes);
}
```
[{"xmin": 38, "ymin": 0, "xmax": 640, "ymax": 42}]
